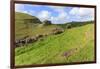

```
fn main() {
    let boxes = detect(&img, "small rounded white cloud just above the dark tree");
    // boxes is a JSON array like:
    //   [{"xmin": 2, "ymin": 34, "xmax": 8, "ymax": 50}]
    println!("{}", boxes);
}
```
[{"xmin": 37, "ymin": 10, "xmax": 51, "ymax": 21}]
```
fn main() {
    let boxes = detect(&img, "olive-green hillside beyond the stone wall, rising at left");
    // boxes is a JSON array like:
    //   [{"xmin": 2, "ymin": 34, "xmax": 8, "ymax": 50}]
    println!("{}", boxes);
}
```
[{"xmin": 15, "ymin": 12, "xmax": 58, "ymax": 39}]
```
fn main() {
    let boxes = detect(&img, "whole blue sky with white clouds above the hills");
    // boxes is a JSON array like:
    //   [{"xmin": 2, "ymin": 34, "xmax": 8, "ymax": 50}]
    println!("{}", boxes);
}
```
[{"xmin": 15, "ymin": 4, "xmax": 94, "ymax": 24}]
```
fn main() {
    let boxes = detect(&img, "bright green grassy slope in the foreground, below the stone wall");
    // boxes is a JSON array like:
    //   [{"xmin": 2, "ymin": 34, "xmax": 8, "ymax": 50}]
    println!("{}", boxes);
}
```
[{"xmin": 15, "ymin": 24, "xmax": 94, "ymax": 65}]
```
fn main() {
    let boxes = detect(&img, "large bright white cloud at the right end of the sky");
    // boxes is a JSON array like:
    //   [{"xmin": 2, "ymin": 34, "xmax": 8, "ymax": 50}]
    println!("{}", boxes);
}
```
[{"xmin": 69, "ymin": 8, "xmax": 94, "ymax": 21}]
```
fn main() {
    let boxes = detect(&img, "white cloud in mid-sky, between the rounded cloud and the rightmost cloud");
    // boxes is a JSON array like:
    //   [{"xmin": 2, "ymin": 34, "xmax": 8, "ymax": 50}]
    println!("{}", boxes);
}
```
[{"xmin": 50, "ymin": 6, "xmax": 69, "ymax": 24}]
